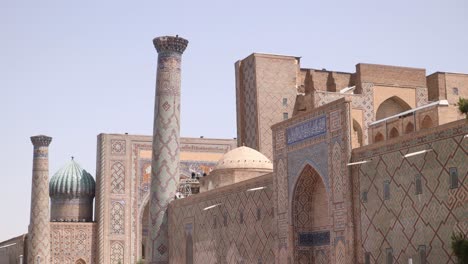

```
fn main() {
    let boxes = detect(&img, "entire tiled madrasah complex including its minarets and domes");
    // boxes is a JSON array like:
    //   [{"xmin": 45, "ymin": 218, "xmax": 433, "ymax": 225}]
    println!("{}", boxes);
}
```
[{"xmin": 0, "ymin": 36, "xmax": 468, "ymax": 264}]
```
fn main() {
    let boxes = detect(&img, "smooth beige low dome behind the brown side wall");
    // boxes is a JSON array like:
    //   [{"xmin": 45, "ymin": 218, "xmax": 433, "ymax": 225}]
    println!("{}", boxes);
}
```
[{"xmin": 214, "ymin": 146, "xmax": 273, "ymax": 170}]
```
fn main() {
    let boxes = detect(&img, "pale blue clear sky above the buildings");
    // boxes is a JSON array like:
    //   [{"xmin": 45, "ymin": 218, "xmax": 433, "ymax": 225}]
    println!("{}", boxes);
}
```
[{"xmin": 0, "ymin": 0, "xmax": 468, "ymax": 241}]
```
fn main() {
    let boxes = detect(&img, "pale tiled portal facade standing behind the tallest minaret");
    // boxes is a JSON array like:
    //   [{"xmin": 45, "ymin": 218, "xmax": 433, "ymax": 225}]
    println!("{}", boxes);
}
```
[{"xmin": 95, "ymin": 134, "xmax": 236, "ymax": 264}]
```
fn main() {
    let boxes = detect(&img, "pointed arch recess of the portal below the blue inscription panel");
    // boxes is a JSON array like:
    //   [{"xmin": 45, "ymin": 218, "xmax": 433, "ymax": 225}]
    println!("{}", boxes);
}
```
[{"xmin": 292, "ymin": 165, "xmax": 331, "ymax": 264}]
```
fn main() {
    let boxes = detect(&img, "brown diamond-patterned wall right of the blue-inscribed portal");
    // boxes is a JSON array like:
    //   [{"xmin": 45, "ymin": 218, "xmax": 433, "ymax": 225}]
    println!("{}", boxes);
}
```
[{"xmin": 352, "ymin": 120, "xmax": 468, "ymax": 264}]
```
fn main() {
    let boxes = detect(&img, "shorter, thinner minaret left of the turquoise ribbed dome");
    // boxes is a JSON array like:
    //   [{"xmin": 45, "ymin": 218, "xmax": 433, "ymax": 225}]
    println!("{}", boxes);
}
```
[{"xmin": 28, "ymin": 135, "xmax": 52, "ymax": 264}]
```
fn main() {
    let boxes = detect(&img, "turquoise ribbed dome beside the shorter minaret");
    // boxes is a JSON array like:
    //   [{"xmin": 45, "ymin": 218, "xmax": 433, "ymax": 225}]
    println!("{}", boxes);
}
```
[{"xmin": 49, "ymin": 159, "xmax": 96, "ymax": 198}]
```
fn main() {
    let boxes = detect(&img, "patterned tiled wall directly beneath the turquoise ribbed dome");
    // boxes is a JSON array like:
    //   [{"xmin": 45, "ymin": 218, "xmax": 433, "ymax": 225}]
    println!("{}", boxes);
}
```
[{"xmin": 50, "ymin": 222, "xmax": 99, "ymax": 264}]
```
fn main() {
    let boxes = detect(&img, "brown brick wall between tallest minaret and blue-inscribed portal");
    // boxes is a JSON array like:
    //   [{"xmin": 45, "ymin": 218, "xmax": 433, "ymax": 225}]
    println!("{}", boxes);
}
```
[{"xmin": 169, "ymin": 174, "xmax": 275, "ymax": 264}]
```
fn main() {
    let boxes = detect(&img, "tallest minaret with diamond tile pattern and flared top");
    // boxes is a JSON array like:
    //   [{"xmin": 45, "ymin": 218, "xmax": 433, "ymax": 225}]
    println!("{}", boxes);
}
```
[{"xmin": 148, "ymin": 36, "xmax": 188, "ymax": 264}]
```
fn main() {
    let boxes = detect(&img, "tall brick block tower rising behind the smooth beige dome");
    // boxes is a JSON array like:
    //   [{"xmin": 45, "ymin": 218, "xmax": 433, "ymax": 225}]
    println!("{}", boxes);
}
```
[{"xmin": 236, "ymin": 54, "xmax": 297, "ymax": 159}]
